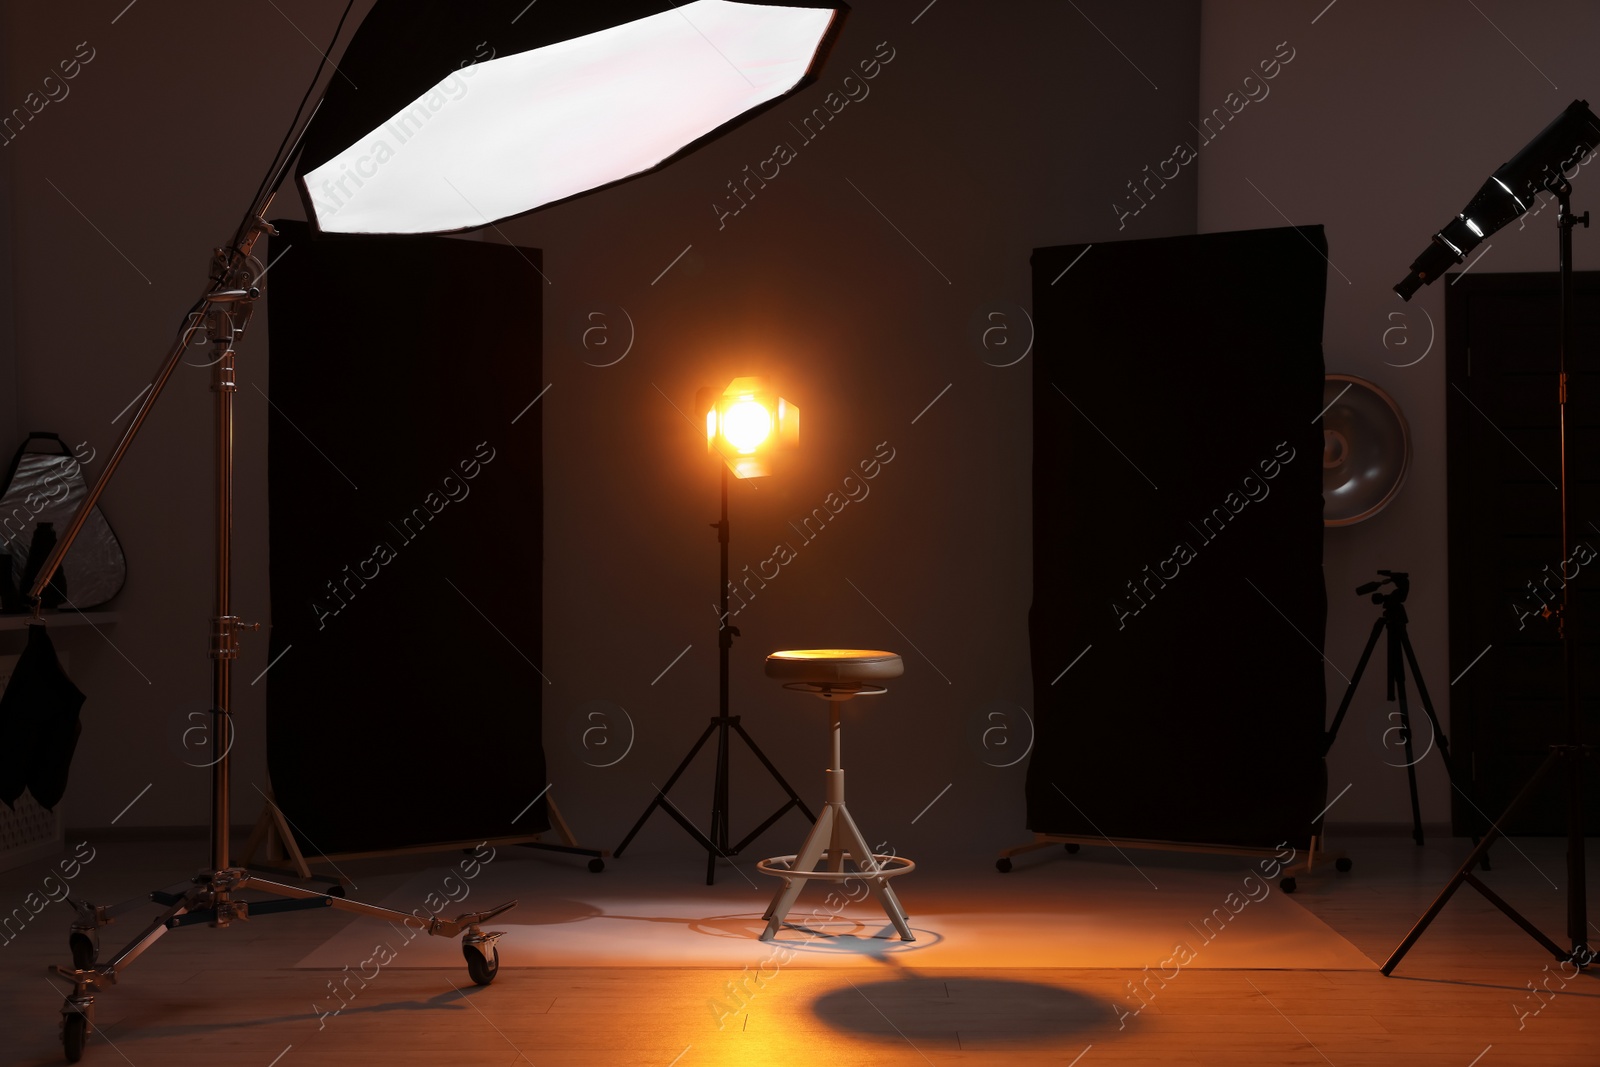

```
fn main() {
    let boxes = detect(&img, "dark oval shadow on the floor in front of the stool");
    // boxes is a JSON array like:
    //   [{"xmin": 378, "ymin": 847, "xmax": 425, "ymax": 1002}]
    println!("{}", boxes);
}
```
[{"xmin": 811, "ymin": 974, "xmax": 1115, "ymax": 1049}]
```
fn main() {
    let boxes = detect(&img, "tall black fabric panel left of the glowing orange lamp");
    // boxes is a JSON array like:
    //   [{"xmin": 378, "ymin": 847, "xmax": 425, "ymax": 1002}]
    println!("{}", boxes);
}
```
[{"xmin": 257, "ymin": 222, "xmax": 547, "ymax": 854}]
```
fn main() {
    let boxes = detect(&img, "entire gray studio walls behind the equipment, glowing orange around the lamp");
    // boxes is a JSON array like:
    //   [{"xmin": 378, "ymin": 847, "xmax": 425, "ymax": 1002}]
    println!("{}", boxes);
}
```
[{"xmin": 0, "ymin": 0, "xmax": 1597, "ymax": 851}]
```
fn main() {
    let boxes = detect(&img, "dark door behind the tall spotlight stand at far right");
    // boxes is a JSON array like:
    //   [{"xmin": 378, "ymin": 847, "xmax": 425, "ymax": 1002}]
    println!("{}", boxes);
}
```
[{"xmin": 1445, "ymin": 267, "xmax": 1600, "ymax": 833}]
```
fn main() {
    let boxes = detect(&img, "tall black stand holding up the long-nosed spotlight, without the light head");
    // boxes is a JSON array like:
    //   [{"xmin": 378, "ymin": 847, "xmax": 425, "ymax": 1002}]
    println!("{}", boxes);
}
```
[{"xmin": 1382, "ymin": 171, "xmax": 1595, "ymax": 976}]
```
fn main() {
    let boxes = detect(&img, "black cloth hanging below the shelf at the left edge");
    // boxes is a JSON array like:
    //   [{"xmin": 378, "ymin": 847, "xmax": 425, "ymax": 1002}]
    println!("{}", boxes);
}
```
[{"xmin": 0, "ymin": 624, "xmax": 83, "ymax": 809}]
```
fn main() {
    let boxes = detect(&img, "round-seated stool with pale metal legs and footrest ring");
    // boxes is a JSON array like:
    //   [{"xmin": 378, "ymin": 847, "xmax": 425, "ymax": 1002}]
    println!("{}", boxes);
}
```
[{"xmin": 755, "ymin": 648, "xmax": 917, "ymax": 941}]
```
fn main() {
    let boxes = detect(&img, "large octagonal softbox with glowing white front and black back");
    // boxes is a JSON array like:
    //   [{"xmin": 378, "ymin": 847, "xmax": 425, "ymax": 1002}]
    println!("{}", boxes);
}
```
[{"xmin": 296, "ymin": 0, "xmax": 846, "ymax": 234}]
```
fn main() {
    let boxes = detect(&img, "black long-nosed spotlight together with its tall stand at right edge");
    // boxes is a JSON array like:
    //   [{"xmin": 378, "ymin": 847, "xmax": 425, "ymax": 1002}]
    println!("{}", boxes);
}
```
[{"xmin": 1381, "ymin": 101, "xmax": 1600, "ymax": 976}]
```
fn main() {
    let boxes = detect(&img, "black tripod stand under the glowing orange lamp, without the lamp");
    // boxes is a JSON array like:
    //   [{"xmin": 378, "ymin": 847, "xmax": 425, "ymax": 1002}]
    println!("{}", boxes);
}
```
[{"xmin": 611, "ymin": 466, "xmax": 816, "ymax": 885}]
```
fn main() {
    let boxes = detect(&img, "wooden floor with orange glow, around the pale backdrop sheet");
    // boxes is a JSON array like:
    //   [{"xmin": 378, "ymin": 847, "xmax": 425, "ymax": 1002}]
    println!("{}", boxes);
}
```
[{"xmin": 0, "ymin": 837, "xmax": 1600, "ymax": 1067}]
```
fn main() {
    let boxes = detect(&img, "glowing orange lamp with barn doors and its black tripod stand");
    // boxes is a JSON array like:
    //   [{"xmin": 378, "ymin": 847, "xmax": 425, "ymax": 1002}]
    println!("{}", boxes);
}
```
[{"xmin": 611, "ymin": 378, "xmax": 816, "ymax": 885}]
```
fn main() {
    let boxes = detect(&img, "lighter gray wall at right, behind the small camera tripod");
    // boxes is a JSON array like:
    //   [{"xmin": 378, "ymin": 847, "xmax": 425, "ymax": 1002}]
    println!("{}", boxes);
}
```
[{"xmin": 1200, "ymin": 0, "xmax": 1600, "ymax": 822}]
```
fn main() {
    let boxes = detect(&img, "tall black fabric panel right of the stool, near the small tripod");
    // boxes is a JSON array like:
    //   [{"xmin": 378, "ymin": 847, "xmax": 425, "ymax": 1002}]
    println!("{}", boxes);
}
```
[{"xmin": 1027, "ymin": 227, "xmax": 1326, "ymax": 846}]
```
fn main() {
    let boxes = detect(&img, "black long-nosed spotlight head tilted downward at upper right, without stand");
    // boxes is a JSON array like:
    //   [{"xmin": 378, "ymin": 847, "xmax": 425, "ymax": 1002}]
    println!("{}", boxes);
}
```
[{"xmin": 1395, "ymin": 101, "xmax": 1600, "ymax": 301}]
